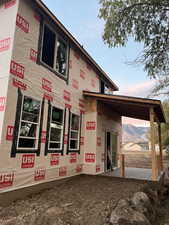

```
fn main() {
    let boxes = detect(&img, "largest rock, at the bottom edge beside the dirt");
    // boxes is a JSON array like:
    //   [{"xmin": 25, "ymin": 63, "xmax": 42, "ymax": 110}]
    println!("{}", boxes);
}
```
[{"xmin": 110, "ymin": 200, "xmax": 150, "ymax": 225}]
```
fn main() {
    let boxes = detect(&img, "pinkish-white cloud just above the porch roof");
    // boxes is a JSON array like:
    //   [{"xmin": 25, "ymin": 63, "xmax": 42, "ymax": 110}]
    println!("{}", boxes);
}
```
[{"xmin": 118, "ymin": 80, "xmax": 156, "ymax": 98}]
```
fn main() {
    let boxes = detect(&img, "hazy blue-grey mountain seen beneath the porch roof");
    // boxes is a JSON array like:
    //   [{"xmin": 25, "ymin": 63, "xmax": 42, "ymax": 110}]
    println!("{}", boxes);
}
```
[{"xmin": 122, "ymin": 124, "xmax": 149, "ymax": 143}]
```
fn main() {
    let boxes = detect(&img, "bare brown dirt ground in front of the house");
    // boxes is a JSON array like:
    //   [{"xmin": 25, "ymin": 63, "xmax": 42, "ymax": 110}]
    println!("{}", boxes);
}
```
[{"xmin": 0, "ymin": 175, "xmax": 152, "ymax": 225}]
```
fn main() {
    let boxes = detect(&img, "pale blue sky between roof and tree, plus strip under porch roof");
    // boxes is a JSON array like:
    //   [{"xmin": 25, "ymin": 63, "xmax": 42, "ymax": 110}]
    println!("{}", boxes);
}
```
[{"xmin": 43, "ymin": 0, "xmax": 158, "ymax": 126}]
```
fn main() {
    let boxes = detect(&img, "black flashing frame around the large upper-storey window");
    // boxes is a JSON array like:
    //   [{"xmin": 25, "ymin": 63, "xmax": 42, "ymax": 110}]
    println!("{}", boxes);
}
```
[{"xmin": 37, "ymin": 17, "xmax": 70, "ymax": 84}]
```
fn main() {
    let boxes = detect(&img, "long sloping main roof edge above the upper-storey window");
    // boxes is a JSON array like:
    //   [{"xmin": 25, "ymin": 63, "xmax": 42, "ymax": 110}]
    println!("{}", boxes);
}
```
[{"xmin": 33, "ymin": 0, "xmax": 119, "ymax": 91}]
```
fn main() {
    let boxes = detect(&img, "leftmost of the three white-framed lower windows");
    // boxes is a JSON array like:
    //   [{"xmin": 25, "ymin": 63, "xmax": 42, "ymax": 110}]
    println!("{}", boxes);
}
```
[{"xmin": 17, "ymin": 96, "xmax": 41, "ymax": 149}]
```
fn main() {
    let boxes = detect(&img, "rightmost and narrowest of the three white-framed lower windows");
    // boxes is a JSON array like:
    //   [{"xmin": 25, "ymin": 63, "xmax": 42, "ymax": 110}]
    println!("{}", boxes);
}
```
[{"xmin": 69, "ymin": 113, "xmax": 80, "ymax": 150}]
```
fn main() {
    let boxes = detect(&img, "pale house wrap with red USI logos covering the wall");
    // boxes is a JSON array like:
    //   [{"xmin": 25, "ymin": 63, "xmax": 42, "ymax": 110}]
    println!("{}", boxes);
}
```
[{"xmin": 0, "ymin": 0, "xmax": 121, "ymax": 192}]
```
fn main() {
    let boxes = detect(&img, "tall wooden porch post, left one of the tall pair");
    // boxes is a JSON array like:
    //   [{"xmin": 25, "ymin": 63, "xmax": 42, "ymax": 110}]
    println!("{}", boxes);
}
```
[{"xmin": 150, "ymin": 108, "xmax": 157, "ymax": 181}]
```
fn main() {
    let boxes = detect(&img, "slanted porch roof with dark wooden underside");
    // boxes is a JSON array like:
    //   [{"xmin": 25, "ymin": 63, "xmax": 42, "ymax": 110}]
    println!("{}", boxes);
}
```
[{"xmin": 83, "ymin": 91, "xmax": 166, "ymax": 123}]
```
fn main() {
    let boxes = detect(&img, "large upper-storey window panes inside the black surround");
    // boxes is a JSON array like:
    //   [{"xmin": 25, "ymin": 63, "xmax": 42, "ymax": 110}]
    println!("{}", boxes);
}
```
[{"xmin": 41, "ymin": 24, "xmax": 68, "ymax": 77}]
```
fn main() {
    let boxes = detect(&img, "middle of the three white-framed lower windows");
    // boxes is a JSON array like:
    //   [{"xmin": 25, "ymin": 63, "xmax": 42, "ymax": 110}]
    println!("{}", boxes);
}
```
[{"xmin": 49, "ymin": 107, "xmax": 64, "ymax": 151}]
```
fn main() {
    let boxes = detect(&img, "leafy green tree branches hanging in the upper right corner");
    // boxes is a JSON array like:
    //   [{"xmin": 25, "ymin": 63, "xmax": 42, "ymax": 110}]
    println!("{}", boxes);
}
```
[{"xmin": 99, "ymin": 0, "xmax": 169, "ymax": 94}]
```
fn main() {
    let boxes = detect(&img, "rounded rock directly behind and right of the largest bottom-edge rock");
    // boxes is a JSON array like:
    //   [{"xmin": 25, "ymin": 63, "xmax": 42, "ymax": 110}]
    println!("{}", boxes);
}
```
[{"xmin": 131, "ymin": 192, "xmax": 156, "ymax": 222}]
